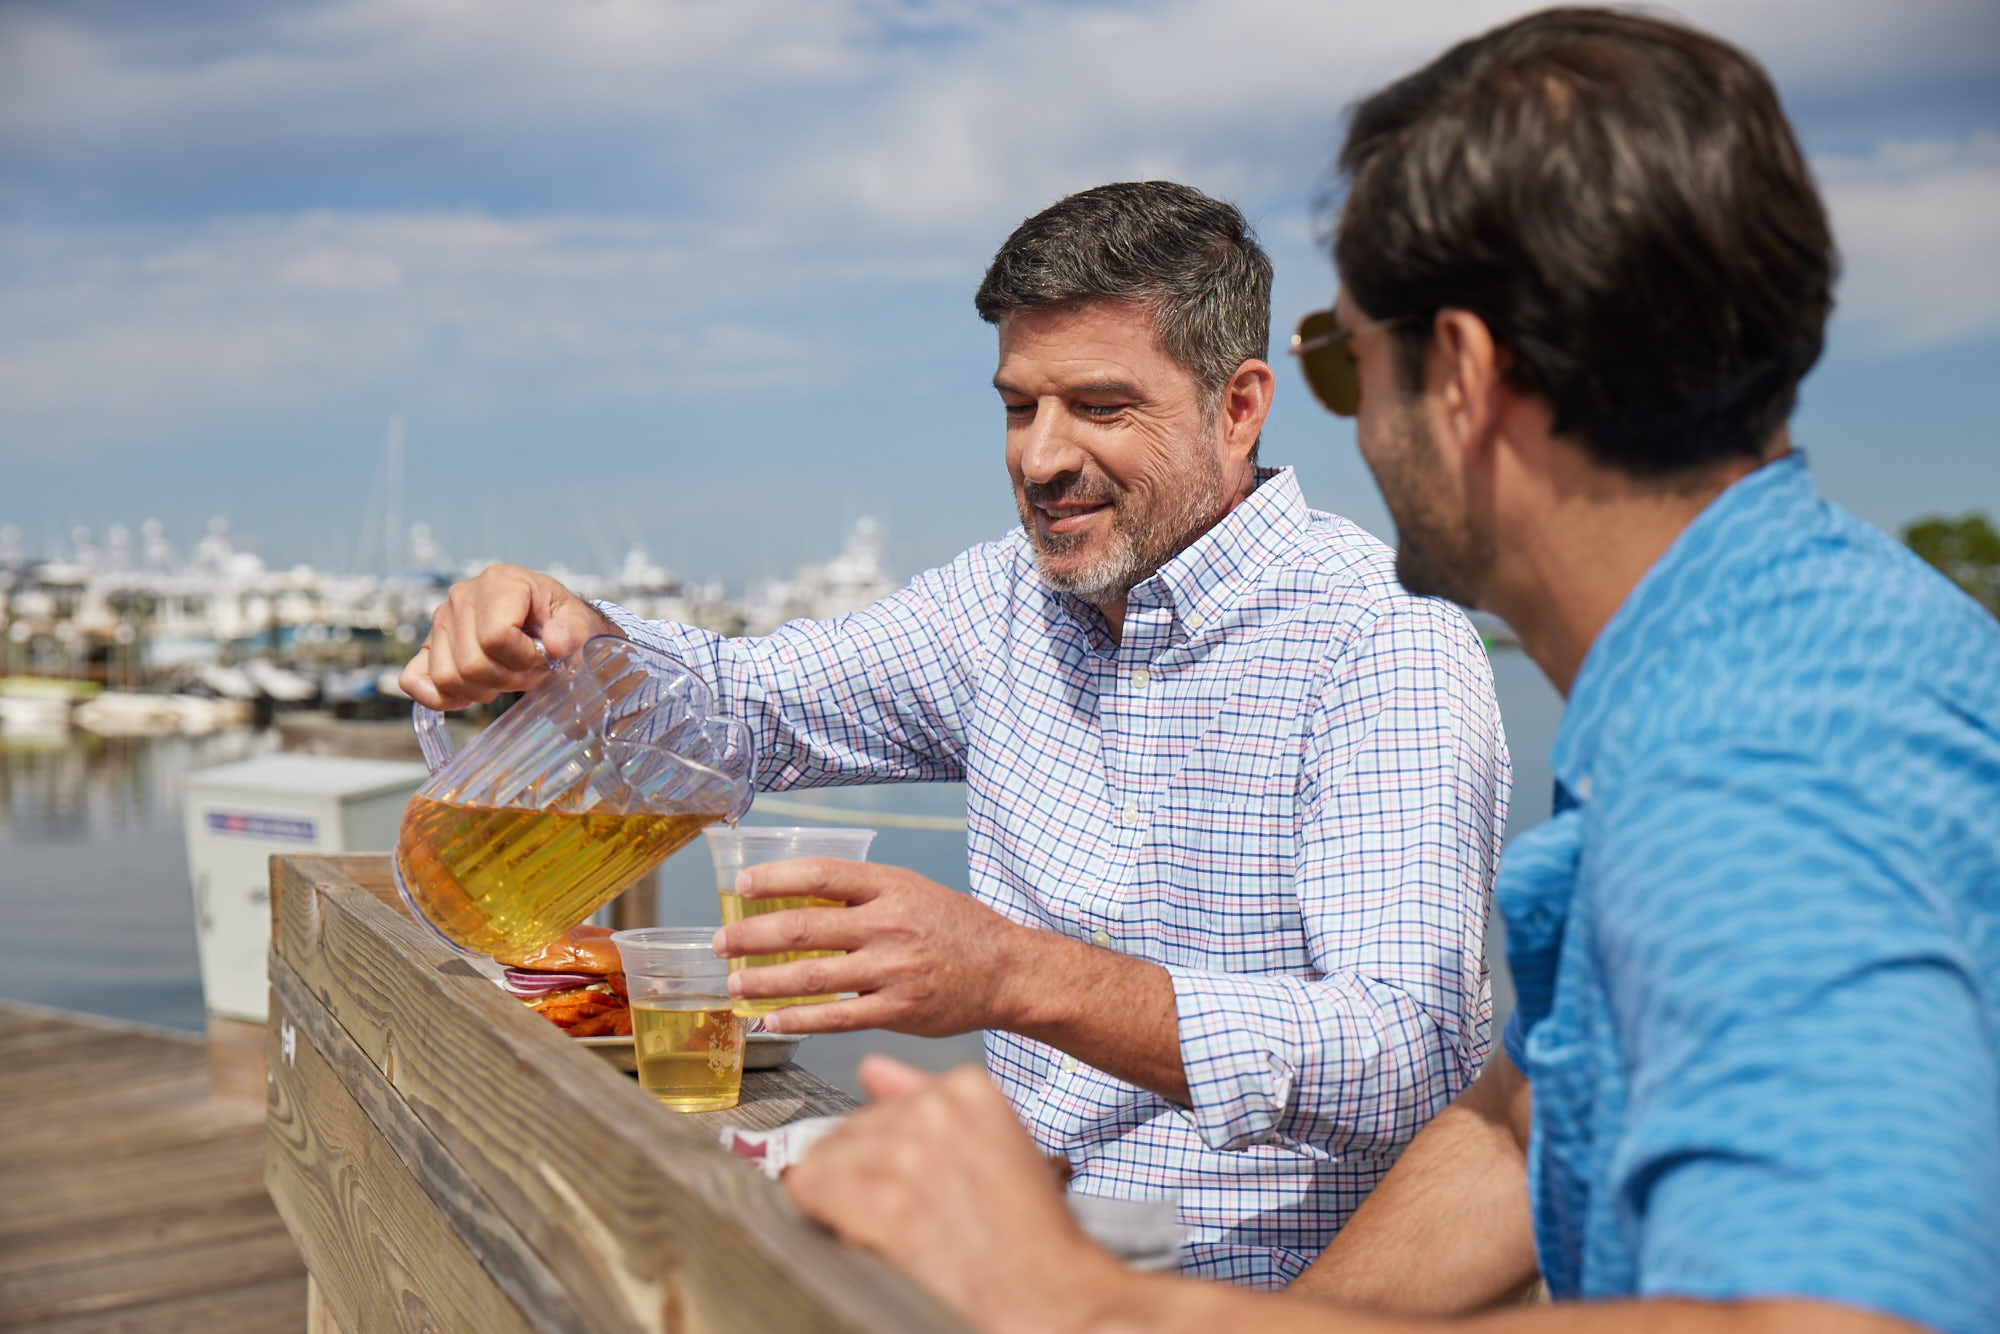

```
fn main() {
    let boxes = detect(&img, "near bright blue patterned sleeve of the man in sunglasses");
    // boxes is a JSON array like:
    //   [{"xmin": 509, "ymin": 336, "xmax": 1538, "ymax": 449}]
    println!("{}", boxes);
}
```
[{"xmin": 1592, "ymin": 750, "xmax": 2000, "ymax": 1332}]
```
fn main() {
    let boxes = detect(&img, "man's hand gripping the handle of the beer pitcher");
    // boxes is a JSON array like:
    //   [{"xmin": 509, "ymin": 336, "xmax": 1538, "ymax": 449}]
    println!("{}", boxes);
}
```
[{"xmin": 398, "ymin": 566, "xmax": 618, "ymax": 708}]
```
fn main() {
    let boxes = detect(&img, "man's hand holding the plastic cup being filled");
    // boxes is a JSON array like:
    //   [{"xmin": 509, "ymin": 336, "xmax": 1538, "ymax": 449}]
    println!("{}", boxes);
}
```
[{"xmin": 716, "ymin": 856, "xmax": 1040, "ymax": 1038}]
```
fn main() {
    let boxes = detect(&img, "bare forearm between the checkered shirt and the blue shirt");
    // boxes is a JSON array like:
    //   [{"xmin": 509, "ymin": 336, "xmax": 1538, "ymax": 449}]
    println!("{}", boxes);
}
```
[{"xmin": 1290, "ymin": 1052, "xmax": 1536, "ymax": 1314}]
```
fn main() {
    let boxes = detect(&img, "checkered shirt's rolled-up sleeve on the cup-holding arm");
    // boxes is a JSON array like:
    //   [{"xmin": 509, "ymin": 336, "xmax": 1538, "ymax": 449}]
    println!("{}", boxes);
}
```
[{"xmin": 1168, "ymin": 604, "xmax": 1512, "ymax": 1158}]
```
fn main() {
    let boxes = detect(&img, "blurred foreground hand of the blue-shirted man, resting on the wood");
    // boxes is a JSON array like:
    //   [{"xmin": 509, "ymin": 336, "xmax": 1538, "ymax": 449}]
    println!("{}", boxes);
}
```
[{"xmin": 780, "ymin": 1056, "xmax": 1126, "ymax": 1334}]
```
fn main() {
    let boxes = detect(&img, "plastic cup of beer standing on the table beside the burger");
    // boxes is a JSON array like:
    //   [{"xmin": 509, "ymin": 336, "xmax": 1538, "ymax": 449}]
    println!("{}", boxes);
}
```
[{"xmin": 612, "ymin": 926, "xmax": 748, "ymax": 1112}]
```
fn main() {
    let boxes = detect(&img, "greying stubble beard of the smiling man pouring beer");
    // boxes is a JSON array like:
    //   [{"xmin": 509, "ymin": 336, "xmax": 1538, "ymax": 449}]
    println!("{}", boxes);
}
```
[{"xmin": 1014, "ymin": 452, "xmax": 1224, "ymax": 606}]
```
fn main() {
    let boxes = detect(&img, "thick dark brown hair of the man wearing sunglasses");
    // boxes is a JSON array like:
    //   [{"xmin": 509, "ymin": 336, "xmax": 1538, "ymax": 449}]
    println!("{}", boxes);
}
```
[{"xmin": 1334, "ymin": 8, "xmax": 1838, "ymax": 476}]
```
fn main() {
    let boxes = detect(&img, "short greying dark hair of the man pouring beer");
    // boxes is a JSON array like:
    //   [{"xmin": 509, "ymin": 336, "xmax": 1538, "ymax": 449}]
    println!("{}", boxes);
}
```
[{"xmin": 972, "ymin": 180, "xmax": 1270, "ymax": 412}]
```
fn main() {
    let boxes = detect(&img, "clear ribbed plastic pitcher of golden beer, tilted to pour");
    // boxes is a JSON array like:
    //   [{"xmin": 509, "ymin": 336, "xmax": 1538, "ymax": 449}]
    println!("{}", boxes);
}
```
[{"xmin": 396, "ymin": 634, "xmax": 754, "ymax": 960}]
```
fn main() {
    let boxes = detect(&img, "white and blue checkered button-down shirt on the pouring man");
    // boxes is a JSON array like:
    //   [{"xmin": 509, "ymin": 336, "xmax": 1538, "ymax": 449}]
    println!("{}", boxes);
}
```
[{"xmin": 606, "ymin": 470, "xmax": 1510, "ymax": 1286}]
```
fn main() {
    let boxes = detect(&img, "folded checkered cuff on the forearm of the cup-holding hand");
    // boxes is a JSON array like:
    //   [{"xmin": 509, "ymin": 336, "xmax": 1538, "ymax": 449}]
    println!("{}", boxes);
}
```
[{"xmin": 1166, "ymin": 968, "xmax": 1330, "ymax": 1158}]
